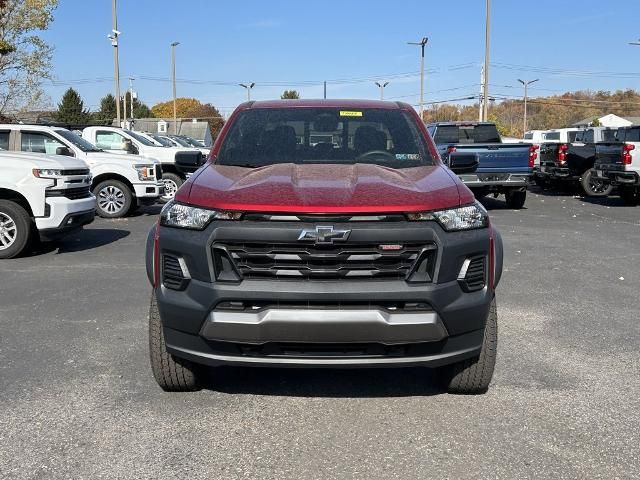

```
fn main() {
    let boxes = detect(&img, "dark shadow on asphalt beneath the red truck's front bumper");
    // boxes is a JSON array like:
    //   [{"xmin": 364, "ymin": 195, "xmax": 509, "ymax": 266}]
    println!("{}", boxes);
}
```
[{"xmin": 203, "ymin": 367, "xmax": 445, "ymax": 398}]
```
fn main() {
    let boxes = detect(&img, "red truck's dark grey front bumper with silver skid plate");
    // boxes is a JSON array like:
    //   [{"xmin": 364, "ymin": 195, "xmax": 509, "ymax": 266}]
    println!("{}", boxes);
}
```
[{"xmin": 147, "ymin": 218, "xmax": 502, "ymax": 367}]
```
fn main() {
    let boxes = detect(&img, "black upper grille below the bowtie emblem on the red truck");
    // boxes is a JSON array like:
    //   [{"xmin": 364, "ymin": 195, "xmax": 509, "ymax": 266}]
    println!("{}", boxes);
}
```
[{"xmin": 214, "ymin": 243, "xmax": 436, "ymax": 282}]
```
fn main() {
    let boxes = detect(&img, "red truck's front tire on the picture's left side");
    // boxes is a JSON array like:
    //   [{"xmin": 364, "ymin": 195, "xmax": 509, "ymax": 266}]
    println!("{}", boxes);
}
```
[{"xmin": 149, "ymin": 292, "xmax": 200, "ymax": 392}]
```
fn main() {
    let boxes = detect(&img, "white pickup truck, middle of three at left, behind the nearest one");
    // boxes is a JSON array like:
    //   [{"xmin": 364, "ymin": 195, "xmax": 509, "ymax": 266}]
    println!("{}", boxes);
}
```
[{"xmin": 0, "ymin": 124, "xmax": 164, "ymax": 218}]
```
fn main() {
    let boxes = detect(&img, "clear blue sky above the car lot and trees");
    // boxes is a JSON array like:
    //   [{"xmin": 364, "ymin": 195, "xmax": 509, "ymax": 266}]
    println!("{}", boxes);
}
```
[{"xmin": 44, "ymin": 0, "xmax": 640, "ymax": 114}]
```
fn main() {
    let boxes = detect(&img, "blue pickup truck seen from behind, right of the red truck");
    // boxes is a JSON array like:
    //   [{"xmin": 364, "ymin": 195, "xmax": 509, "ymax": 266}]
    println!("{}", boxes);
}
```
[{"xmin": 427, "ymin": 122, "xmax": 538, "ymax": 209}]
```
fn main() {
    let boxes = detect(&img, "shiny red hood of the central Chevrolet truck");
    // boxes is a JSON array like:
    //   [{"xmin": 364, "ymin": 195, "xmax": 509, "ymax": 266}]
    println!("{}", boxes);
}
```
[{"xmin": 176, "ymin": 163, "xmax": 473, "ymax": 213}]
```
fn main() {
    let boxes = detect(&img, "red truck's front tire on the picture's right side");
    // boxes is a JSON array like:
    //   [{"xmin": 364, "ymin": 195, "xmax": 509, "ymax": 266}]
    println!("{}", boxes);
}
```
[{"xmin": 440, "ymin": 298, "xmax": 498, "ymax": 395}]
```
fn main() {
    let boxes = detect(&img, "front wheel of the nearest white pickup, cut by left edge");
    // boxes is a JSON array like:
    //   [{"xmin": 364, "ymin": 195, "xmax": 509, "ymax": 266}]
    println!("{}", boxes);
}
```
[{"xmin": 0, "ymin": 200, "xmax": 32, "ymax": 259}]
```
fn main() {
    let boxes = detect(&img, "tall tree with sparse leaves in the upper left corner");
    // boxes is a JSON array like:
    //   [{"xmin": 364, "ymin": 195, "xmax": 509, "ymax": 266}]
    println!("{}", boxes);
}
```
[{"xmin": 0, "ymin": 0, "xmax": 58, "ymax": 114}]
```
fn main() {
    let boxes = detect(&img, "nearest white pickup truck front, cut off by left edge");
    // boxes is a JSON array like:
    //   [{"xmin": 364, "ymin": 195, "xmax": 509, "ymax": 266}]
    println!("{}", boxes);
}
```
[{"xmin": 0, "ymin": 151, "xmax": 96, "ymax": 259}]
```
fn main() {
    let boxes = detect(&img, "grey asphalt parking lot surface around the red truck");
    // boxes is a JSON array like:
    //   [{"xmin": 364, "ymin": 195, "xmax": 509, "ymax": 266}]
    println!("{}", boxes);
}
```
[{"xmin": 0, "ymin": 192, "xmax": 640, "ymax": 479}]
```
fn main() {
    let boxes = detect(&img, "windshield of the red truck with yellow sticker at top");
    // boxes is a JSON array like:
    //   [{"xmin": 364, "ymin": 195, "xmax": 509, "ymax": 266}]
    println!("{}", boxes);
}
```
[{"xmin": 216, "ymin": 108, "xmax": 434, "ymax": 168}]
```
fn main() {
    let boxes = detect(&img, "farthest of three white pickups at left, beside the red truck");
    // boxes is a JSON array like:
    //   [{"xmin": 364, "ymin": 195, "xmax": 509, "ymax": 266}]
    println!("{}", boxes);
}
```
[{"xmin": 82, "ymin": 126, "xmax": 200, "ymax": 202}]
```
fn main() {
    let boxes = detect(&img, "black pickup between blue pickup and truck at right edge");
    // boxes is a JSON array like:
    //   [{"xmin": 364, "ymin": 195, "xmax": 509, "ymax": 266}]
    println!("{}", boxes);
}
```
[{"xmin": 540, "ymin": 127, "xmax": 620, "ymax": 197}]
